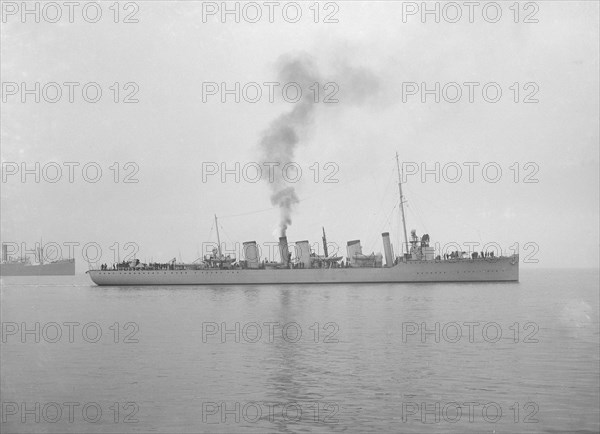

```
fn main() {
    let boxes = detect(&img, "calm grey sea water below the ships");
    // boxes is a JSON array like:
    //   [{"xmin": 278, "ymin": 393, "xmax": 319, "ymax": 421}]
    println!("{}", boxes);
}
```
[{"xmin": 0, "ymin": 270, "xmax": 600, "ymax": 433}]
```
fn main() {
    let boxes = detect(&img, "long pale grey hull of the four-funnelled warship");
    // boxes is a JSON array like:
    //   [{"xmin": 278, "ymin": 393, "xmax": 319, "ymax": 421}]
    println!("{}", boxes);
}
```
[{"xmin": 88, "ymin": 255, "xmax": 519, "ymax": 286}]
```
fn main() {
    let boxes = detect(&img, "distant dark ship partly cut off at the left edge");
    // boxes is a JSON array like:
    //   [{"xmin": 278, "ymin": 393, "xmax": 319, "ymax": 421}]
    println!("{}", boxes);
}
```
[{"xmin": 0, "ymin": 244, "xmax": 75, "ymax": 276}]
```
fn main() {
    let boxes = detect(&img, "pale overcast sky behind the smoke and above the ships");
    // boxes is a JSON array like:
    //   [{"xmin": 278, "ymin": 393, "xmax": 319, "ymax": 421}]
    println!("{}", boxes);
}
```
[{"xmin": 1, "ymin": 1, "xmax": 600, "ymax": 271}]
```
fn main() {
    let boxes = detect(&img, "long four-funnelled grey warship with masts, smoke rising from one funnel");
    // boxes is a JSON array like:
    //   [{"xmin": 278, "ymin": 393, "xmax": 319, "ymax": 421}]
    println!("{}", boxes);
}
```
[{"xmin": 87, "ymin": 154, "xmax": 519, "ymax": 286}]
